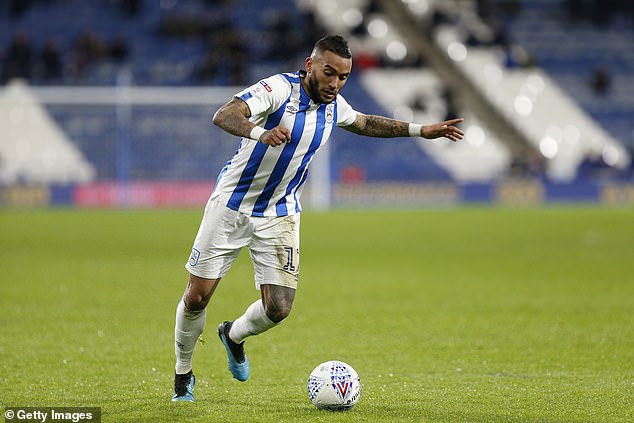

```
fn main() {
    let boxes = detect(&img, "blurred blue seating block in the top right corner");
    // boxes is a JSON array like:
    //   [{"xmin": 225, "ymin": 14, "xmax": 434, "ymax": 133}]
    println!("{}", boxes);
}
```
[{"xmin": 505, "ymin": 0, "xmax": 634, "ymax": 157}]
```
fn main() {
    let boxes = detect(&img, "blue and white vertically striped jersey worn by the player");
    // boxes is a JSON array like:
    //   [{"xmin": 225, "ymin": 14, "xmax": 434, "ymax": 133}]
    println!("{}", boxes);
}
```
[{"xmin": 212, "ymin": 72, "xmax": 357, "ymax": 216}]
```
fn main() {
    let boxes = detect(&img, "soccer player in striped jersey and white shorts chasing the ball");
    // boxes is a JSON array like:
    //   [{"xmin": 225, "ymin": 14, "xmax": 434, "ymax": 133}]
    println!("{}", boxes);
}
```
[{"xmin": 172, "ymin": 35, "xmax": 464, "ymax": 401}]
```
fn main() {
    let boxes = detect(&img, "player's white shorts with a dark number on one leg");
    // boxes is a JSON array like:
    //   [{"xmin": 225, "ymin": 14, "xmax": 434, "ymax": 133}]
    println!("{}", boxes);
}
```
[{"xmin": 185, "ymin": 197, "xmax": 299, "ymax": 289}]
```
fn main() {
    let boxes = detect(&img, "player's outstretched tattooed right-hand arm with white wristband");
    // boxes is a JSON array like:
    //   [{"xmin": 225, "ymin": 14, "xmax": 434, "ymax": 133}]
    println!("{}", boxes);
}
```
[{"xmin": 343, "ymin": 113, "xmax": 464, "ymax": 141}]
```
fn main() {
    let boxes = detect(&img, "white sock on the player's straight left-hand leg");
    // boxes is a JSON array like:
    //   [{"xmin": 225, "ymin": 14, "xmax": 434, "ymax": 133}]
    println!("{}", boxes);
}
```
[{"xmin": 174, "ymin": 300, "xmax": 206, "ymax": 375}]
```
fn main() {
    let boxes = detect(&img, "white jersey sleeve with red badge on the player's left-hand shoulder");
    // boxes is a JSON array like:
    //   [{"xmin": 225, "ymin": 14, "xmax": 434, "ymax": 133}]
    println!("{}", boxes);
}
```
[{"xmin": 235, "ymin": 75, "xmax": 291, "ymax": 119}]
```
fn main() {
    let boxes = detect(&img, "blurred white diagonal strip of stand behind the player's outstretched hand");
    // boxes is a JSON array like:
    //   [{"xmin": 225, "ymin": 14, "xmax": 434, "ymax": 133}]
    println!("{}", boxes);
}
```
[{"xmin": 304, "ymin": 0, "xmax": 511, "ymax": 183}]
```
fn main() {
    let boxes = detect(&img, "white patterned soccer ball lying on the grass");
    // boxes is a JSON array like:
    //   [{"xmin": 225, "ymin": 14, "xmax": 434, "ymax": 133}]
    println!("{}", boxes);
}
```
[{"xmin": 308, "ymin": 361, "xmax": 361, "ymax": 411}]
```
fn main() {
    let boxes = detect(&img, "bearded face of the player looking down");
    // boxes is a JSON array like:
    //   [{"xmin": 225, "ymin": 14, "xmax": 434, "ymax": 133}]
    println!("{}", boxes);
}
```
[{"xmin": 306, "ymin": 51, "xmax": 352, "ymax": 103}]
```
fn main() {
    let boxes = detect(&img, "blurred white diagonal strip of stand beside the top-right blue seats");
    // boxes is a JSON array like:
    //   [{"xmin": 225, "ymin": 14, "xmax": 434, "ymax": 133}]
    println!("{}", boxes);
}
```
[{"xmin": 380, "ymin": 0, "xmax": 631, "ymax": 182}]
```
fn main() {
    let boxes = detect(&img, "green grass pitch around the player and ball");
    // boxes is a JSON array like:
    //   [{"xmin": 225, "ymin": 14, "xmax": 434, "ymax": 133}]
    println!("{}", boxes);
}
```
[{"xmin": 0, "ymin": 207, "xmax": 634, "ymax": 423}]
